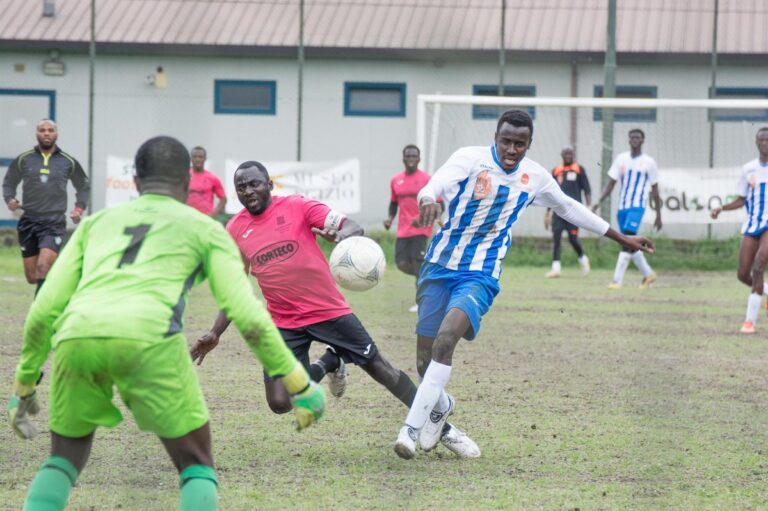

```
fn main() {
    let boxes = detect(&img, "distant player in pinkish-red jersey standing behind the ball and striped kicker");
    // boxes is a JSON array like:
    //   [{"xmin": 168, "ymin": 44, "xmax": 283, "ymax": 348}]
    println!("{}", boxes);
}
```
[{"xmin": 384, "ymin": 144, "xmax": 432, "ymax": 312}]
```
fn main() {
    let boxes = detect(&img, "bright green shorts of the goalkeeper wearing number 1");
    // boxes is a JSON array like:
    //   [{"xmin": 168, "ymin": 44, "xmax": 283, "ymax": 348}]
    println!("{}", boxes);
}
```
[{"xmin": 49, "ymin": 334, "xmax": 208, "ymax": 438}]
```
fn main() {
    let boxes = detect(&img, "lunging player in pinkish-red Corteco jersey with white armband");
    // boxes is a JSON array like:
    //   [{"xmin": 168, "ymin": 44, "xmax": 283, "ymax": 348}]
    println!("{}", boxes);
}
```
[{"xmin": 192, "ymin": 161, "xmax": 477, "ymax": 456}]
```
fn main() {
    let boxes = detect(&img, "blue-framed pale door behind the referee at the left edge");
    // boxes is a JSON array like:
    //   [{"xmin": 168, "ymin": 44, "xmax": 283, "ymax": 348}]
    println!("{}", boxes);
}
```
[{"xmin": 0, "ymin": 89, "xmax": 56, "ymax": 226}]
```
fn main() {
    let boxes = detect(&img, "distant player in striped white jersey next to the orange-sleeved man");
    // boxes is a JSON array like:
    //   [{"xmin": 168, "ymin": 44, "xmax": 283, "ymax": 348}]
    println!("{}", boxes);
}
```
[{"xmin": 592, "ymin": 128, "xmax": 661, "ymax": 289}]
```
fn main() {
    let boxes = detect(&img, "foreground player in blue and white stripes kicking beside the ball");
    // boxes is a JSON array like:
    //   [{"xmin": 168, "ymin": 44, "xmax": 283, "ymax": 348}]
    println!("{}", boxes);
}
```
[{"xmin": 395, "ymin": 110, "xmax": 653, "ymax": 459}]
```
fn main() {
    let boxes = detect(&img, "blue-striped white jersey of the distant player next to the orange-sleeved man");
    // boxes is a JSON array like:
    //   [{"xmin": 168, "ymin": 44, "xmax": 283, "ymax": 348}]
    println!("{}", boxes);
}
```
[{"xmin": 608, "ymin": 151, "xmax": 659, "ymax": 209}]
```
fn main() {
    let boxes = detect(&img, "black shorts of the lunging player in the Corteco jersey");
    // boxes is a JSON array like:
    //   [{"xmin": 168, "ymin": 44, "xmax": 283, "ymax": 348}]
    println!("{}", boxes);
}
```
[{"xmin": 264, "ymin": 314, "xmax": 379, "ymax": 381}]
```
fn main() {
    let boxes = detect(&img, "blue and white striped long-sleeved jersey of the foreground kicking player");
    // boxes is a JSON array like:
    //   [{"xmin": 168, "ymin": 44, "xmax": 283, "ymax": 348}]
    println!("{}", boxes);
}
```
[{"xmin": 418, "ymin": 145, "xmax": 609, "ymax": 278}]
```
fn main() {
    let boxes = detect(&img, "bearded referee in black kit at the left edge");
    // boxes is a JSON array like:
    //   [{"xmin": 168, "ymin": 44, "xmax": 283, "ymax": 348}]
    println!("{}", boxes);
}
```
[{"xmin": 3, "ymin": 119, "xmax": 91, "ymax": 294}]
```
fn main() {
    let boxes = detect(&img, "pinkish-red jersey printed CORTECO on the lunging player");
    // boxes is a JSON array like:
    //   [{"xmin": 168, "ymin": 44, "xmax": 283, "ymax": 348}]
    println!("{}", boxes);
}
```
[{"xmin": 227, "ymin": 195, "xmax": 352, "ymax": 328}]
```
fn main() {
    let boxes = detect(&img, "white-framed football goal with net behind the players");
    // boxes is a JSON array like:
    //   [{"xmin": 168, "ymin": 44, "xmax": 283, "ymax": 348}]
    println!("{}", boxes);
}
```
[{"xmin": 417, "ymin": 94, "xmax": 768, "ymax": 239}]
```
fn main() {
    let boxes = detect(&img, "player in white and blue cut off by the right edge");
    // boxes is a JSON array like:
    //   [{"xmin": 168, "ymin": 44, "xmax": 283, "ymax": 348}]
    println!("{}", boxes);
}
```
[{"xmin": 711, "ymin": 126, "xmax": 768, "ymax": 334}]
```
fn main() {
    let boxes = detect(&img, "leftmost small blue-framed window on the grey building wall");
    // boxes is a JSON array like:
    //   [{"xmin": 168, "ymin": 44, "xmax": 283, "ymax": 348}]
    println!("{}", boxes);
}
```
[{"xmin": 213, "ymin": 80, "xmax": 277, "ymax": 115}]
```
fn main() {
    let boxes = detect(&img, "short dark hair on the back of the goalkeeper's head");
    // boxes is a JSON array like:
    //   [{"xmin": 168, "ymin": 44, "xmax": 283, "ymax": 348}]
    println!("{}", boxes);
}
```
[{"xmin": 134, "ymin": 136, "xmax": 189, "ymax": 183}]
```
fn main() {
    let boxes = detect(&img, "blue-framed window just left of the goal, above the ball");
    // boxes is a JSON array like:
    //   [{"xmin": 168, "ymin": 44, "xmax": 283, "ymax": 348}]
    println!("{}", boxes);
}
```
[{"xmin": 344, "ymin": 82, "xmax": 405, "ymax": 117}]
